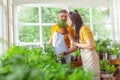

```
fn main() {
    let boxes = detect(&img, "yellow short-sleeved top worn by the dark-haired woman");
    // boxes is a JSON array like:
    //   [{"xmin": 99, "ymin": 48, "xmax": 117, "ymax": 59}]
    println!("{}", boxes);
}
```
[{"xmin": 80, "ymin": 26, "xmax": 94, "ymax": 44}]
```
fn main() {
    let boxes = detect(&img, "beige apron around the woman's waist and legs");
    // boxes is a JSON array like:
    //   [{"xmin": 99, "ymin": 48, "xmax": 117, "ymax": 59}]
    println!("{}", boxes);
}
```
[{"xmin": 81, "ymin": 49, "xmax": 100, "ymax": 80}]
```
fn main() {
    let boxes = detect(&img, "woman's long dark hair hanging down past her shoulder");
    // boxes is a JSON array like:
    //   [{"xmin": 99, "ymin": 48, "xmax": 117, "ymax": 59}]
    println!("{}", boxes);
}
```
[{"xmin": 68, "ymin": 10, "xmax": 83, "ymax": 42}]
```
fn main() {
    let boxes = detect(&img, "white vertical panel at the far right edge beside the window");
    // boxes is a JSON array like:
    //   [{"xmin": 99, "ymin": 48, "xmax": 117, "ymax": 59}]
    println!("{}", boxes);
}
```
[{"xmin": 112, "ymin": 0, "xmax": 120, "ymax": 42}]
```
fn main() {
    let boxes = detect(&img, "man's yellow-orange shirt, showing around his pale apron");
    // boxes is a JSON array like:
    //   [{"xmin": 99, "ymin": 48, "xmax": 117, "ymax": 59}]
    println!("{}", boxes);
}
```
[{"xmin": 51, "ymin": 24, "xmax": 75, "ymax": 48}]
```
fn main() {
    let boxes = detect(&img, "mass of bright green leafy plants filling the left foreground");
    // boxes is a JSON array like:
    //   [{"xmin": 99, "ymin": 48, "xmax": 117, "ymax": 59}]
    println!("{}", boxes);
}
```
[{"xmin": 0, "ymin": 44, "xmax": 92, "ymax": 80}]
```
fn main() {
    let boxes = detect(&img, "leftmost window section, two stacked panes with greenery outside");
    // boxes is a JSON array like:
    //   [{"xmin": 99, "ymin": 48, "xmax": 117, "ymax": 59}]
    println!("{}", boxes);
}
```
[{"xmin": 15, "ymin": 6, "xmax": 41, "ymax": 46}]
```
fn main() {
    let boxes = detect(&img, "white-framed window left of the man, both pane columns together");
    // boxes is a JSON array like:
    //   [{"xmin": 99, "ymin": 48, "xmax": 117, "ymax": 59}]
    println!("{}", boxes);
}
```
[{"xmin": 15, "ymin": 6, "xmax": 60, "ymax": 46}]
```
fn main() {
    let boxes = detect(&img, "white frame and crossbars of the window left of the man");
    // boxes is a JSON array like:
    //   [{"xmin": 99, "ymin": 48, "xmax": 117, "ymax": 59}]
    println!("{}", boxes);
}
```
[{"xmin": 14, "ymin": 4, "xmax": 61, "ymax": 47}]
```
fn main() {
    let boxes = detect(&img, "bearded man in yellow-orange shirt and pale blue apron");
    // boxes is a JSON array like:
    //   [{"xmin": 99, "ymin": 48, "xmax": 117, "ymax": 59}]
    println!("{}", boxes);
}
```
[{"xmin": 49, "ymin": 9, "xmax": 75, "ymax": 63}]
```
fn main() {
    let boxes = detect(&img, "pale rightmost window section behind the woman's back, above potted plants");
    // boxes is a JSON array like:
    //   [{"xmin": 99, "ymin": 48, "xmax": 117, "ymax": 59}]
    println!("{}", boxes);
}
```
[{"xmin": 92, "ymin": 7, "xmax": 112, "ymax": 39}]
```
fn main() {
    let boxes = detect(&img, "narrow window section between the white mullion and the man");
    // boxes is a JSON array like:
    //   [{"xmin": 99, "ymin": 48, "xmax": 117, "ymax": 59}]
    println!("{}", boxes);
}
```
[{"xmin": 41, "ymin": 7, "xmax": 60, "ymax": 42}]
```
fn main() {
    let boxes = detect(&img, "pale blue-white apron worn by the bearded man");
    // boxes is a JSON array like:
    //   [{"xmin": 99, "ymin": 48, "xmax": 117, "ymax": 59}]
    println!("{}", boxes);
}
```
[{"xmin": 52, "ymin": 31, "xmax": 71, "ymax": 63}]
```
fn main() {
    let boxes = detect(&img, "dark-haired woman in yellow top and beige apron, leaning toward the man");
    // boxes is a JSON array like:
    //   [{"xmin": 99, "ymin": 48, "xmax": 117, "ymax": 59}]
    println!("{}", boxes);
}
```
[{"xmin": 62, "ymin": 11, "xmax": 100, "ymax": 80}]
